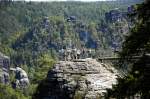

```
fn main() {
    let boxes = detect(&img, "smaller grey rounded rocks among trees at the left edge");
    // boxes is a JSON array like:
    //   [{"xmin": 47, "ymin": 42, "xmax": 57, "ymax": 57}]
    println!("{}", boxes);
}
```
[{"xmin": 0, "ymin": 52, "xmax": 29, "ymax": 88}]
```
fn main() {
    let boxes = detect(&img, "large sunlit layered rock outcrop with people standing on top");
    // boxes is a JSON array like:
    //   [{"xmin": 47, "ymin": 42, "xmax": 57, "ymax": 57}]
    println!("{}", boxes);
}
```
[{"xmin": 35, "ymin": 59, "xmax": 118, "ymax": 99}]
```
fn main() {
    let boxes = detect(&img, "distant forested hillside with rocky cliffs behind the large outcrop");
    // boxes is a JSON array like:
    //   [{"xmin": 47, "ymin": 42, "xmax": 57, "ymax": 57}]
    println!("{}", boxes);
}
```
[{"xmin": 0, "ymin": 0, "xmax": 142, "ymax": 83}]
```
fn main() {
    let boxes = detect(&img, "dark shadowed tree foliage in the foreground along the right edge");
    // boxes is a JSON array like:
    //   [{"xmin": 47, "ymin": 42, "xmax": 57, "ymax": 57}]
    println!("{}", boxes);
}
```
[{"xmin": 107, "ymin": 1, "xmax": 150, "ymax": 99}]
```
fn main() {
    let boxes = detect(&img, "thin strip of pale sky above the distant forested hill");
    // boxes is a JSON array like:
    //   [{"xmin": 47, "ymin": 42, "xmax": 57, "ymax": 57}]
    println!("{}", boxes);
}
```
[{"xmin": 14, "ymin": 0, "xmax": 115, "ymax": 2}]
